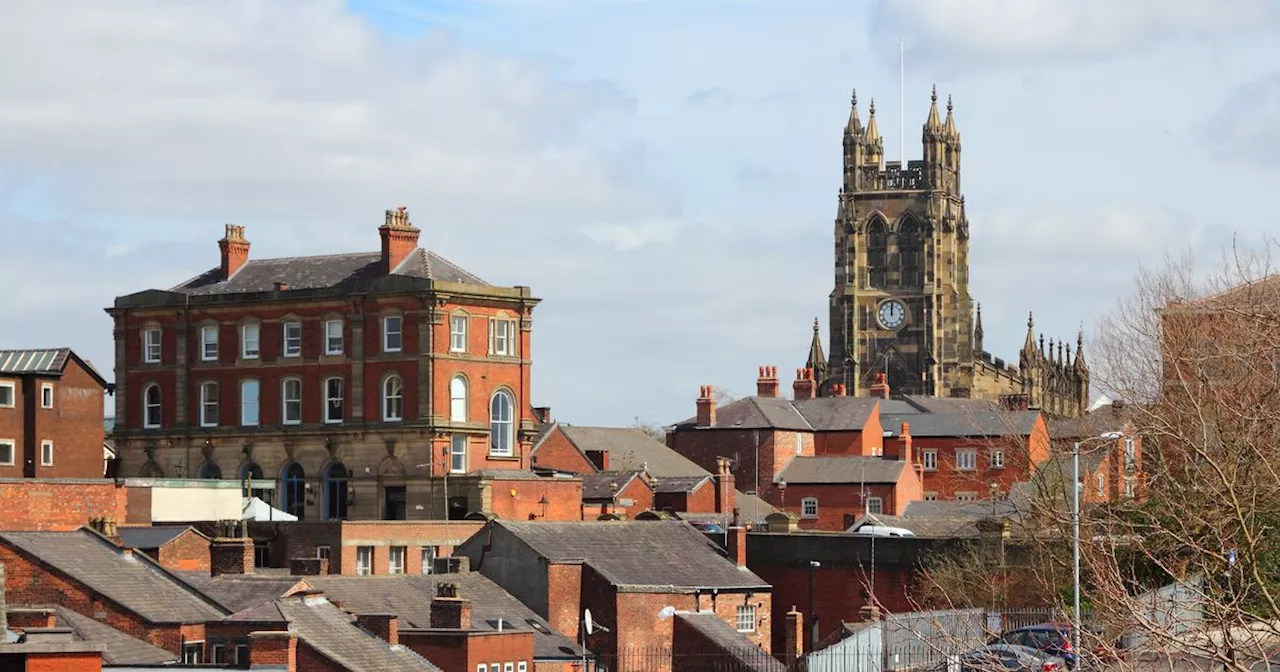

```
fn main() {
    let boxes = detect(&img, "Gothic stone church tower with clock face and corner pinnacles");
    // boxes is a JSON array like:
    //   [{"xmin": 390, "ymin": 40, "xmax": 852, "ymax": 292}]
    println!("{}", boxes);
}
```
[{"xmin": 824, "ymin": 87, "xmax": 980, "ymax": 397}]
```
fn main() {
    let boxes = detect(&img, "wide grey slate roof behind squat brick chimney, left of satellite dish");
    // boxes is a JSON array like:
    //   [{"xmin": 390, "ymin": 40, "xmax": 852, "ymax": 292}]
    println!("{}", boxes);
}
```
[{"xmin": 307, "ymin": 572, "xmax": 581, "ymax": 659}]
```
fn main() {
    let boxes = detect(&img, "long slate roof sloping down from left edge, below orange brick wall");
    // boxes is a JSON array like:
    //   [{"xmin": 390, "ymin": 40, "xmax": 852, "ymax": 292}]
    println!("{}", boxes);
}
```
[{"xmin": 0, "ymin": 530, "xmax": 225, "ymax": 623}]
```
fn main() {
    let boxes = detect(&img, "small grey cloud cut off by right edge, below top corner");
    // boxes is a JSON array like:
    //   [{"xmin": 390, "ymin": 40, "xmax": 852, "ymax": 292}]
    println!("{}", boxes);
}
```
[{"xmin": 1201, "ymin": 70, "xmax": 1280, "ymax": 166}]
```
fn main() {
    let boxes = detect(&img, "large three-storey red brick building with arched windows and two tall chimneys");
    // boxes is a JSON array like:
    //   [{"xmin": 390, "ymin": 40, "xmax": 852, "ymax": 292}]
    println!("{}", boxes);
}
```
[{"xmin": 108, "ymin": 207, "xmax": 539, "ymax": 520}]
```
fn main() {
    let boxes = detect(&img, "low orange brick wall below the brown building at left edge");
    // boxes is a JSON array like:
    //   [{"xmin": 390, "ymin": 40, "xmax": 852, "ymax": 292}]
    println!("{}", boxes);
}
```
[{"xmin": 0, "ymin": 478, "xmax": 129, "ymax": 531}]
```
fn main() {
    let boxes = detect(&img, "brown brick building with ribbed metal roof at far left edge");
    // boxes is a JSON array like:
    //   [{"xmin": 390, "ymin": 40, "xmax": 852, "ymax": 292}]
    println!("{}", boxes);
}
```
[{"xmin": 0, "ymin": 348, "xmax": 113, "ymax": 479}]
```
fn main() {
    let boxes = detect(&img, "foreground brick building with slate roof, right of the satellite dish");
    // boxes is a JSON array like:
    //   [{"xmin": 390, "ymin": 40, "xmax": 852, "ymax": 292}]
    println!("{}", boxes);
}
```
[{"xmin": 458, "ymin": 521, "xmax": 773, "ymax": 672}]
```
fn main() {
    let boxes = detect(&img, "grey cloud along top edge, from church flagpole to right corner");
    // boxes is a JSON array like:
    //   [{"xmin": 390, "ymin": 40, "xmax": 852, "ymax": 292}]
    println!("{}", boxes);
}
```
[{"xmin": 870, "ymin": 0, "xmax": 1280, "ymax": 65}]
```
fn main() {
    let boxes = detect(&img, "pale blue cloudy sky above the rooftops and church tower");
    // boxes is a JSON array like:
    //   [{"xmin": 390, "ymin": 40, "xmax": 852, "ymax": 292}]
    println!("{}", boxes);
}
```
[{"xmin": 0, "ymin": 0, "xmax": 1280, "ymax": 425}]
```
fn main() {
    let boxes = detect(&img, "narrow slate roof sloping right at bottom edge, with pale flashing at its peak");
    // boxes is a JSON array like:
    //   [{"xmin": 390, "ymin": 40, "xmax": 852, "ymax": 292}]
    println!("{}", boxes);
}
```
[{"xmin": 275, "ymin": 595, "xmax": 439, "ymax": 672}]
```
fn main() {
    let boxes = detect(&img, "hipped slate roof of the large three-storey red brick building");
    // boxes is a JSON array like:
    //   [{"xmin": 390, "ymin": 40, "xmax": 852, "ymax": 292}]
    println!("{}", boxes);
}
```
[{"xmin": 170, "ymin": 248, "xmax": 489, "ymax": 294}]
